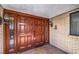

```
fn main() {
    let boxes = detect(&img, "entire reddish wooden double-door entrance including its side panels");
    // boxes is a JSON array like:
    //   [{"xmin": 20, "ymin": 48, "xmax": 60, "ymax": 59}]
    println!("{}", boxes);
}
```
[{"xmin": 4, "ymin": 9, "xmax": 49, "ymax": 53}]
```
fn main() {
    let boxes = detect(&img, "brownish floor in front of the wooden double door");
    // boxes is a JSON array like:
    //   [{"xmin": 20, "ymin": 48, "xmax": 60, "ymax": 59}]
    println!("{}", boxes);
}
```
[{"xmin": 22, "ymin": 44, "xmax": 66, "ymax": 54}]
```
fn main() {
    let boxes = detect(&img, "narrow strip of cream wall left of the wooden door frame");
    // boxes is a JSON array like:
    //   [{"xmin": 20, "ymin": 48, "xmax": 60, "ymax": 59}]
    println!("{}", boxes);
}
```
[{"xmin": 0, "ymin": 7, "xmax": 3, "ymax": 54}]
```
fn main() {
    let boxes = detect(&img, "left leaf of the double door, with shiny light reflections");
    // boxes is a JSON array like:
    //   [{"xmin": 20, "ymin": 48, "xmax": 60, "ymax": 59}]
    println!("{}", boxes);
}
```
[{"xmin": 17, "ymin": 16, "xmax": 33, "ymax": 51}]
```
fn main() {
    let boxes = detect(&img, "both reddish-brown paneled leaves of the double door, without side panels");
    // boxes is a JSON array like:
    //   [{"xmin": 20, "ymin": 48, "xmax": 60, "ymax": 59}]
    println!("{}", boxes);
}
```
[{"xmin": 16, "ymin": 17, "xmax": 45, "ymax": 50}]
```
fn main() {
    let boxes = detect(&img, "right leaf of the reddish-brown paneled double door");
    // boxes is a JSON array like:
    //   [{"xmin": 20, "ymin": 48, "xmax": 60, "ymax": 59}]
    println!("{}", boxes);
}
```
[{"xmin": 34, "ymin": 19, "xmax": 44, "ymax": 46}]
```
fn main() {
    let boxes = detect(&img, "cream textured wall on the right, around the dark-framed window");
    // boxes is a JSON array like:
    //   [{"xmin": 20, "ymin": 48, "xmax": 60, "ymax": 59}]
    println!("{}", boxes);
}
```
[{"xmin": 50, "ymin": 9, "xmax": 79, "ymax": 53}]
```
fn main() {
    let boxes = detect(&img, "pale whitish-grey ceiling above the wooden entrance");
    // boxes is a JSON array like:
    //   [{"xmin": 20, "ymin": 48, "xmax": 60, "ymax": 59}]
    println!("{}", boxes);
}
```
[{"xmin": 2, "ymin": 4, "xmax": 79, "ymax": 18}]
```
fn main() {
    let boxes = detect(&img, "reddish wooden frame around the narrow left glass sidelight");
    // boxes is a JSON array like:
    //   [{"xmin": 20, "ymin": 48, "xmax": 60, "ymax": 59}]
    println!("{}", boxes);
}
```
[{"xmin": 3, "ymin": 9, "xmax": 17, "ymax": 54}]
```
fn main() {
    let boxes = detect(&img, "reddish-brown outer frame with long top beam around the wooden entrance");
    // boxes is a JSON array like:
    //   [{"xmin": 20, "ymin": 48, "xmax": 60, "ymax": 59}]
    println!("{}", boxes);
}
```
[{"xmin": 3, "ymin": 9, "xmax": 50, "ymax": 54}]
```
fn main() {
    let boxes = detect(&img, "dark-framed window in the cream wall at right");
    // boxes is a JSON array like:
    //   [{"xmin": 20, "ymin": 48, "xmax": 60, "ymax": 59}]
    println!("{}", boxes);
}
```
[{"xmin": 70, "ymin": 11, "xmax": 79, "ymax": 35}]
